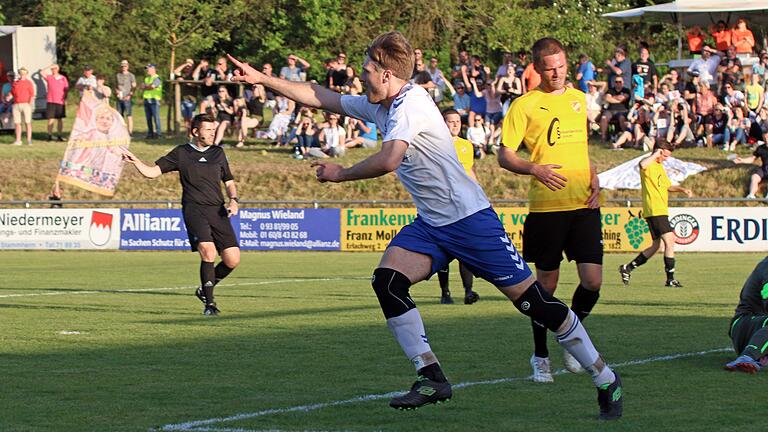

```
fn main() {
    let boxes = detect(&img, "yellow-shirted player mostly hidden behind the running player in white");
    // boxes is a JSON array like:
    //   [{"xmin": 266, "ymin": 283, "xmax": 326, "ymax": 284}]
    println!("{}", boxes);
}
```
[{"xmin": 437, "ymin": 108, "xmax": 480, "ymax": 304}]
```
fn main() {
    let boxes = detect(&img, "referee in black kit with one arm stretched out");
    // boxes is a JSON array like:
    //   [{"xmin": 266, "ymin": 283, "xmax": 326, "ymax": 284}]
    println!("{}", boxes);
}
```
[{"xmin": 123, "ymin": 114, "xmax": 240, "ymax": 315}]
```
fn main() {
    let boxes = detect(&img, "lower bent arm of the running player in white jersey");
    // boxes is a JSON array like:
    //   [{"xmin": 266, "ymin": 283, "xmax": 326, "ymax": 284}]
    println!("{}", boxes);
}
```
[{"xmin": 312, "ymin": 140, "xmax": 408, "ymax": 183}]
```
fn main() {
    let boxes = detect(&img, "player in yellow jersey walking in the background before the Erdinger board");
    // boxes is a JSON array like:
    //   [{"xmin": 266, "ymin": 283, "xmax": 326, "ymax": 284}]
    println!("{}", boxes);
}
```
[{"xmin": 619, "ymin": 142, "xmax": 693, "ymax": 288}]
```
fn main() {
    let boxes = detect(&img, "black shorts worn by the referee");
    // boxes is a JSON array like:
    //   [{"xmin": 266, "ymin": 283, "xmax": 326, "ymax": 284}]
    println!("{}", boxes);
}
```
[{"xmin": 182, "ymin": 204, "xmax": 237, "ymax": 253}]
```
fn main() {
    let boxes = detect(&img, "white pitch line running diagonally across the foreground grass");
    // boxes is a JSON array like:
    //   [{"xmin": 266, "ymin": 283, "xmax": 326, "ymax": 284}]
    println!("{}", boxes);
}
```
[{"xmin": 159, "ymin": 347, "xmax": 733, "ymax": 432}]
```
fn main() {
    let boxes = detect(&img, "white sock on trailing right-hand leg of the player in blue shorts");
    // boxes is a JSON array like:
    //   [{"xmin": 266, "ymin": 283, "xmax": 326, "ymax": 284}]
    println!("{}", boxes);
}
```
[{"xmin": 556, "ymin": 310, "xmax": 615, "ymax": 387}]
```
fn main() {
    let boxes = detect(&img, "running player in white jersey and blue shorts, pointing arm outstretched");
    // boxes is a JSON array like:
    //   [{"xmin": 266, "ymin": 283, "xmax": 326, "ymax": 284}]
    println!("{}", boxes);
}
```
[{"xmin": 225, "ymin": 32, "xmax": 623, "ymax": 419}]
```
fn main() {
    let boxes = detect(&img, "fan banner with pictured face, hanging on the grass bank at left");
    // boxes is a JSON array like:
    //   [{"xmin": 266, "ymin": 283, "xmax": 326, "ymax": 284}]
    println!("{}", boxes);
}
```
[{"xmin": 56, "ymin": 92, "xmax": 131, "ymax": 196}]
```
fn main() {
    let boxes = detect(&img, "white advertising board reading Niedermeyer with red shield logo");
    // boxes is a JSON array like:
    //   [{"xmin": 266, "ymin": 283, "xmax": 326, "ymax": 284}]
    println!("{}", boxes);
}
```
[{"xmin": 0, "ymin": 209, "xmax": 120, "ymax": 249}]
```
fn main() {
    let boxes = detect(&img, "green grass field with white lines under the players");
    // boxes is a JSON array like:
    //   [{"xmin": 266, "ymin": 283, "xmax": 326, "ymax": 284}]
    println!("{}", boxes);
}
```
[{"xmin": 0, "ymin": 251, "xmax": 768, "ymax": 432}]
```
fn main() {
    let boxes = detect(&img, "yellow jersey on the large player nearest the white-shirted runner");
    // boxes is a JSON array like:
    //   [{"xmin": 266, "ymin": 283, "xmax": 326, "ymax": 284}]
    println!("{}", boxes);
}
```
[{"xmin": 501, "ymin": 88, "xmax": 592, "ymax": 212}]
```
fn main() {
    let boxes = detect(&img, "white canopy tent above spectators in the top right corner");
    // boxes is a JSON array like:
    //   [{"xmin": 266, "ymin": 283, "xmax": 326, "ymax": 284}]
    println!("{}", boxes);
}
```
[{"xmin": 603, "ymin": 0, "xmax": 768, "ymax": 59}]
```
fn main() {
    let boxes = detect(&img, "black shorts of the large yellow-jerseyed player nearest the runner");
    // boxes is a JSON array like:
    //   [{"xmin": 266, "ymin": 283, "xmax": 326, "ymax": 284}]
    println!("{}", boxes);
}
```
[{"xmin": 523, "ymin": 209, "xmax": 603, "ymax": 271}]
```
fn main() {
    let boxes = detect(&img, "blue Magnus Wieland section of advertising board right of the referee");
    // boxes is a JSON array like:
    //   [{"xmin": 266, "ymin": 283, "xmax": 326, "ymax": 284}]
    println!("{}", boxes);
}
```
[{"xmin": 235, "ymin": 209, "xmax": 341, "ymax": 250}]
